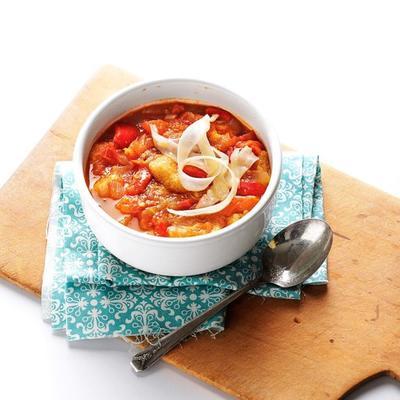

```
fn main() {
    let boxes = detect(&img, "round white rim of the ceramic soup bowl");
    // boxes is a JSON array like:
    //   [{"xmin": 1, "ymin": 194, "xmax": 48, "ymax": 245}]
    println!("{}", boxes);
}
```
[{"xmin": 73, "ymin": 78, "xmax": 282, "ymax": 245}]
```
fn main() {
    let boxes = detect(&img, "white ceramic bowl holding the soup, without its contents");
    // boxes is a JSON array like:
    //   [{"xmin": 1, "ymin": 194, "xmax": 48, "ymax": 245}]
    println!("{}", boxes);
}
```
[{"xmin": 73, "ymin": 79, "xmax": 281, "ymax": 275}]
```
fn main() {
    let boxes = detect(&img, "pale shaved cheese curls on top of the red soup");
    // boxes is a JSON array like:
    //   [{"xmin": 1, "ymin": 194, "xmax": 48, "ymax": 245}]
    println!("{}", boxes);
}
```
[{"xmin": 150, "ymin": 115, "xmax": 258, "ymax": 217}]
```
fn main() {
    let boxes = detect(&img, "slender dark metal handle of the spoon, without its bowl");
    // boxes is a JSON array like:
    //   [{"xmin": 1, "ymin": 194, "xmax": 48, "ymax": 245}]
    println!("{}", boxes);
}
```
[{"xmin": 131, "ymin": 279, "xmax": 259, "ymax": 372}]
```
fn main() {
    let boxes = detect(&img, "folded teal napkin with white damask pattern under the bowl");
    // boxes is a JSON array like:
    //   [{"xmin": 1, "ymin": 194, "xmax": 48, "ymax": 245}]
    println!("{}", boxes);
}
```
[{"xmin": 42, "ymin": 153, "xmax": 327, "ymax": 340}]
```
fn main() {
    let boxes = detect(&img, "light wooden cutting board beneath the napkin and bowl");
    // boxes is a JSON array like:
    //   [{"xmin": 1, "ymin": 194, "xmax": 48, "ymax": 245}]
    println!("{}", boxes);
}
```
[{"xmin": 0, "ymin": 66, "xmax": 400, "ymax": 399}]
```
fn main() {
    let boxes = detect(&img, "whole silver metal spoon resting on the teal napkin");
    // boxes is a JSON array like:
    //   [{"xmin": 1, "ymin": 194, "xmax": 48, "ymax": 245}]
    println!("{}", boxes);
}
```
[{"xmin": 131, "ymin": 219, "xmax": 332, "ymax": 372}]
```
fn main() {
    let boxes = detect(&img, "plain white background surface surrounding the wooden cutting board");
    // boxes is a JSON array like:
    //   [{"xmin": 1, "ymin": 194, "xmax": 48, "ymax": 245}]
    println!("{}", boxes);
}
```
[{"xmin": 0, "ymin": 0, "xmax": 400, "ymax": 400}]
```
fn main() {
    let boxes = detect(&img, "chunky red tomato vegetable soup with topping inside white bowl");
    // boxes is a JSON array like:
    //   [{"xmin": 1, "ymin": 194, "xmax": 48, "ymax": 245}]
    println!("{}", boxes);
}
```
[{"xmin": 87, "ymin": 101, "xmax": 270, "ymax": 238}]
